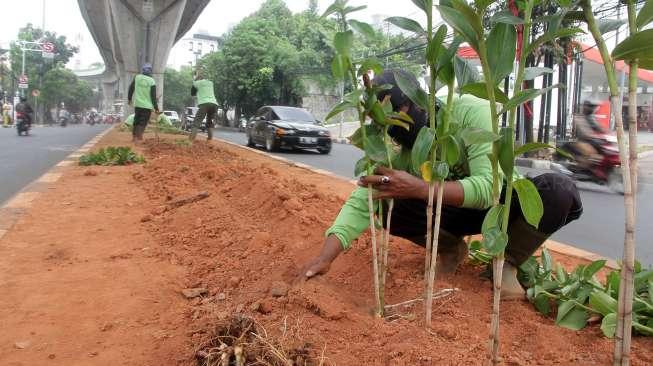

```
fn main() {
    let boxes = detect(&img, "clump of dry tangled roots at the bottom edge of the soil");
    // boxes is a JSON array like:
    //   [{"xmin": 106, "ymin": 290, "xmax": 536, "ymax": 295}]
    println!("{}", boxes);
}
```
[{"xmin": 195, "ymin": 316, "xmax": 322, "ymax": 366}]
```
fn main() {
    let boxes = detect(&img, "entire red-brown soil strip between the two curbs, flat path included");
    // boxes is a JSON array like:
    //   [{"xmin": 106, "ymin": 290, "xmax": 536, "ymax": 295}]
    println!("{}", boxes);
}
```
[{"xmin": 0, "ymin": 127, "xmax": 653, "ymax": 365}]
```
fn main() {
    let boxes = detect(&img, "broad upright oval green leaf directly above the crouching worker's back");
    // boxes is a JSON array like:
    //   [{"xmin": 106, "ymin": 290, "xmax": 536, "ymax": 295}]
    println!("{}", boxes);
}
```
[{"xmin": 486, "ymin": 23, "xmax": 517, "ymax": 82}]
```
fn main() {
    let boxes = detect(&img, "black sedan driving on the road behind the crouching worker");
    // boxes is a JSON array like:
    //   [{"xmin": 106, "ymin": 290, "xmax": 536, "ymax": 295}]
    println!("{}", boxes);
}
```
[{"xmin": 246, "ymin": 106, "xmax": 331, "ymax": 154}]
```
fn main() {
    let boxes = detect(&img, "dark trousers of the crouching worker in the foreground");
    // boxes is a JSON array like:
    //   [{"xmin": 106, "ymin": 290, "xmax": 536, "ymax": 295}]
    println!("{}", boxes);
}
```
[{"xmin": 383, "ymin": 173, "xmax": 583, "ymax": 264}]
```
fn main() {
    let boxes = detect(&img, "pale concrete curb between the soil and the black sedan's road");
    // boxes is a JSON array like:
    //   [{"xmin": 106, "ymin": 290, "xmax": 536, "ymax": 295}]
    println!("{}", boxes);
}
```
[{"xmin": 209, "ymin": 134, "xmax": 619, "ymax": 269}]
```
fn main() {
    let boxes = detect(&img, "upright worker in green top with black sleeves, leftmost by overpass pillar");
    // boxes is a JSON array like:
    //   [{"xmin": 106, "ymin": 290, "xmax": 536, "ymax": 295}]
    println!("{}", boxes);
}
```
[{"xmin": 127, "ymin": 63, "xmax": 159, "ymax": 142}]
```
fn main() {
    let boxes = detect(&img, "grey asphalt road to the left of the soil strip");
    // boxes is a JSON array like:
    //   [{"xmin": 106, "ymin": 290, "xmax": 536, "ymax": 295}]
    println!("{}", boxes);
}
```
[{"xmin": 0, "ymin": 125, "xmax": 109, "ymax": 203}]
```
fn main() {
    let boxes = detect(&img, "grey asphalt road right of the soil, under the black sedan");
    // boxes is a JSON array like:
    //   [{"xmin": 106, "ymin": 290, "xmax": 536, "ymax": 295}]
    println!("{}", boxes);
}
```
[{"xmin": 217, "ymin": 130, "xmax": 653, "ymax": 265}]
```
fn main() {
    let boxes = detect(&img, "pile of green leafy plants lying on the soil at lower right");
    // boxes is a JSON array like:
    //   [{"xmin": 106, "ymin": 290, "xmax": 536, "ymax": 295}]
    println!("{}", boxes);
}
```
[{"xmin": 469, "ymin": 242, "xmax": 653, "ymax": 338}]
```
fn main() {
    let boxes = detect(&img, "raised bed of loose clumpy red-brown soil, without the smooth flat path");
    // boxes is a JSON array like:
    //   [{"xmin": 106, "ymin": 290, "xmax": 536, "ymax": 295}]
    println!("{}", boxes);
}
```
[{"xmin": 133, "ymin": 133, "xmax": 653, "ymax": 365}]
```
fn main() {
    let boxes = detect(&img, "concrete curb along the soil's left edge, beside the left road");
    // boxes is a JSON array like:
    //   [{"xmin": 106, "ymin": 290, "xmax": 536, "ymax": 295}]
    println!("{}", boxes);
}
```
[{"xmin": 0, "ymin": 127, "xmax": 113, "ymax": 239}]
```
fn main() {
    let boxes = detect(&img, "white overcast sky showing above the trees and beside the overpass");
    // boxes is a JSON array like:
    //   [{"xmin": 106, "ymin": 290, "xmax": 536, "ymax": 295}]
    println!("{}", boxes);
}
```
[{"xmin": 0, "ymin": 0, "xmax": 421, "ymax": 68}]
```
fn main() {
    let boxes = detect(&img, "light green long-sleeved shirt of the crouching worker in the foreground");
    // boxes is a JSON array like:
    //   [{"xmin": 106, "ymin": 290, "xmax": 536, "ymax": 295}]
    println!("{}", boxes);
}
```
[{"xmin": 326, "ymin": 95, "xmax": 510, "ymax": 249}]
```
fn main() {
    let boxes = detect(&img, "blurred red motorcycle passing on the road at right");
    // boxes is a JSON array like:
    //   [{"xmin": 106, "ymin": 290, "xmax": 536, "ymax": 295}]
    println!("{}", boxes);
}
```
[{"xmin": 551, "ymin": 134, "xmax": 624, "ymax": 194}]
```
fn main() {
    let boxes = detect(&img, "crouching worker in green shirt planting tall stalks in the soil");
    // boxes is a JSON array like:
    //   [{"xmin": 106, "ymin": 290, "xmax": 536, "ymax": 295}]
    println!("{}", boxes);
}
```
[{"xmin": 300, "ymin": 71, "xmax": 582, "ymax": 299}]
